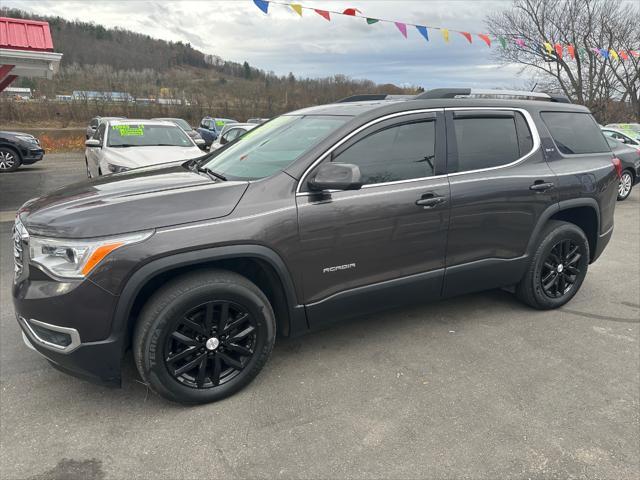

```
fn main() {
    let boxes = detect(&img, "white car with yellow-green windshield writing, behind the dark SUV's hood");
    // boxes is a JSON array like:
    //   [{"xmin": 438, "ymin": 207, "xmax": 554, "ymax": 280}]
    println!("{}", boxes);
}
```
[{"xmin": 85, "ymin": 120, "xmax": 202, "ymax": 178}]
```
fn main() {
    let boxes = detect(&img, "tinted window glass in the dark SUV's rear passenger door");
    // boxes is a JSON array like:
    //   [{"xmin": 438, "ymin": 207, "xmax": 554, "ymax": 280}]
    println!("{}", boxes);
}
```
[{"xmin": 453, "ymin": 113, "xmax": 533, "ymax": 172}]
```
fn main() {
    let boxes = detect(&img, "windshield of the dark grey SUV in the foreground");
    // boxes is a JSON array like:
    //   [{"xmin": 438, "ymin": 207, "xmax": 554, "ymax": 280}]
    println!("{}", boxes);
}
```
[{"xmin": 203, "ymin": 115, "xmax": 351, "ymax": 180}]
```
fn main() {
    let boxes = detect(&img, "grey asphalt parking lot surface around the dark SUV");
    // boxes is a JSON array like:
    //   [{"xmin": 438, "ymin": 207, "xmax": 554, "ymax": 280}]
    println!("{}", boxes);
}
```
[{"xmin": 0, "ymin": 153, "xmax": 640, "ymax": 480}]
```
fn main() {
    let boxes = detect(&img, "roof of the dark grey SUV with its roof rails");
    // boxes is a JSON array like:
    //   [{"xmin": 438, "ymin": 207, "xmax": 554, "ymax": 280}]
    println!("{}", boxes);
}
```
[{"xmin": 286, "ymin": 98, "xmax": 589, "ymax": 117}]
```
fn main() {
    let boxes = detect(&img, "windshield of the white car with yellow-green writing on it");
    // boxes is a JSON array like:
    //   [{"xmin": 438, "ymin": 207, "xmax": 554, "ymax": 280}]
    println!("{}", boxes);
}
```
[{"xmin": 108, "ymin": 124, "xmax": 193, "ymax": 147}]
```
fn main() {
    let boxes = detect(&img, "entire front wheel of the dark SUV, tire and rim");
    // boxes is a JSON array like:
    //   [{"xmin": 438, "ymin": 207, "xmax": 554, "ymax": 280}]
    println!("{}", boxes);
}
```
[{"xmin": 133, "ymin": 270, "xmax": 276, "ymax": 404}]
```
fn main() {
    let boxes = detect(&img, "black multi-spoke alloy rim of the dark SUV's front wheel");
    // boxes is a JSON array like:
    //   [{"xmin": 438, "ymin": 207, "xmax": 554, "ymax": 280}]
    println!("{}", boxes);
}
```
[{"xmin": 164, "ymin": 301, "xmax": 256, "ymax": 389}]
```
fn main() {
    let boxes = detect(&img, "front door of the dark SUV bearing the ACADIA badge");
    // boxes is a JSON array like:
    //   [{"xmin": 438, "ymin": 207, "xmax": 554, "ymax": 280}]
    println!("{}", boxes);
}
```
[{"xmin": 296, "ymin": 111, "xmax": 449, "ymax": 327}]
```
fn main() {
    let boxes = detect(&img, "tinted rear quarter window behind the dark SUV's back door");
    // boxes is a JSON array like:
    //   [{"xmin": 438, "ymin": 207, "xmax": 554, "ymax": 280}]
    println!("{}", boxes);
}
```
[{"xmin": 541, "ymin": 112, "xmax": 611, "ymax": 155}]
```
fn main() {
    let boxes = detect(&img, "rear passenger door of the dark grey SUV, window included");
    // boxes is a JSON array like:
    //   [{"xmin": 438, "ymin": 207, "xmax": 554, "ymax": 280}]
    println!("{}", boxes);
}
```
[{"xmin": 444, "ymin": 108, "xmax": 557, "ymax": 295}]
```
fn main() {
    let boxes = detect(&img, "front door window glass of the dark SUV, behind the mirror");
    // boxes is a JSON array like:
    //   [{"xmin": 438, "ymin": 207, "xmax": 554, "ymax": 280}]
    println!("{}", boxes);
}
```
[{"xmin": 333, "ymin": 120, "xmax": 435, "ymax": 185}]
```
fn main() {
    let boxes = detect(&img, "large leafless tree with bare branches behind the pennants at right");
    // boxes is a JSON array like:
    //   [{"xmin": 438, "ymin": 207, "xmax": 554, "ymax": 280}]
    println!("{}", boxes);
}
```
[{"xmin": 487, "ymin": 0, "xmax": 640, "ymax": 118}]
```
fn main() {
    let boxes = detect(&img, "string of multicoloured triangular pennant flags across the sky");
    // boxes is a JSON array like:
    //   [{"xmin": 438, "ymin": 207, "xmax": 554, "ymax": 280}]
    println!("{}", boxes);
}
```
[{"xmin": 253, "ymin": 0, "xmax": 640, "ymax": 61}]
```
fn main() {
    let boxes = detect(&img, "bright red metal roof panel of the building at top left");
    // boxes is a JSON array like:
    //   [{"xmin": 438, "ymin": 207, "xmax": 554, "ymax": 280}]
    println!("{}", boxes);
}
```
[{"xmin": 0, "ymin": 17, "xmax": 53, "ymax": 52}]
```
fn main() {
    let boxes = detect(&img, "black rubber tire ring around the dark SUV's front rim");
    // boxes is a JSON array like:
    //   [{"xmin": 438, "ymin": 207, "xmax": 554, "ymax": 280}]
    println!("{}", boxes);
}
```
[{"xmin": 141, "ymin": 283, "xmax": 275, "ymax": 403}]
